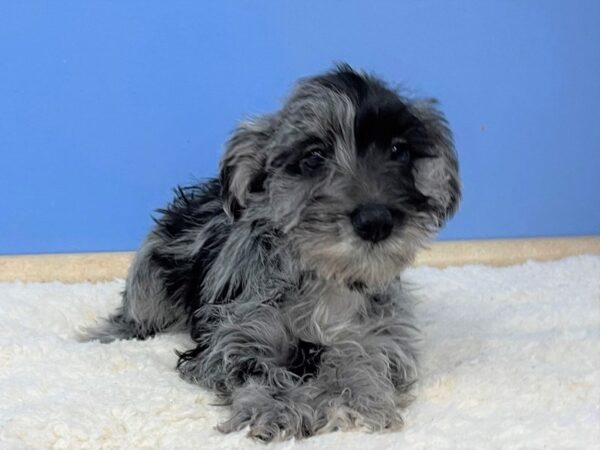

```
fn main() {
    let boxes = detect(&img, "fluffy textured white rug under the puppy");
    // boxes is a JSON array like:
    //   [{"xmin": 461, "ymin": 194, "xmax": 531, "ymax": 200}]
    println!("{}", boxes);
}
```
[{"xmin": 0, "ymin": 256, "xmax": 600, "ymax": 450}]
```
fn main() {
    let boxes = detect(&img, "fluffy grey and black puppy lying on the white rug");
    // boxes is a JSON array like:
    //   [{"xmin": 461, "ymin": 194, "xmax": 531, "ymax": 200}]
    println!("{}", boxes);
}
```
[{"xmin": 87, "ymin": 65, "xmax": 460, "ymax": 441}]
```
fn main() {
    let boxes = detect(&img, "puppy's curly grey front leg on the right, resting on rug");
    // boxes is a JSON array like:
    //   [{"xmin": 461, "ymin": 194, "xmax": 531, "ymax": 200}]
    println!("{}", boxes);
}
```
[{"xmin": 315, "ymin": 320, "xmax": 417, "ymax": 431}]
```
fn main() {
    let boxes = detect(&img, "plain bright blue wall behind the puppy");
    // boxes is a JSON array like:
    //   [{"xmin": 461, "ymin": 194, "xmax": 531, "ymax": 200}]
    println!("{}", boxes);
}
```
[{"xmin": 0, "ymin": 0, "xmax": 600, "ymax": 253}]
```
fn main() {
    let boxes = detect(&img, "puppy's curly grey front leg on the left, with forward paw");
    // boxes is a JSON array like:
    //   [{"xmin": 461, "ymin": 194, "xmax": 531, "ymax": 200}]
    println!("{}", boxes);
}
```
[{"xmin": 178, "ymin": 302, "xmax": 325, "ymax": 441}]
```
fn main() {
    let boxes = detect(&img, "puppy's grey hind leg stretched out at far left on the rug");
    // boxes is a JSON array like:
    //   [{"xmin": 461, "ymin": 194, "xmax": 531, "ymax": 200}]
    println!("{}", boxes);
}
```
[{"xmin": 80, "ymin": 234, "xmax": 186, "ymax": 343}]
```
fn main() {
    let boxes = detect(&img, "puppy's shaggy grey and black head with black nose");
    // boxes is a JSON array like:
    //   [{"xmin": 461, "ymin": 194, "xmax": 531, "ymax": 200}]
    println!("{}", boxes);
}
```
[{"xmin": 221, "ymin": 65, "xmax": 460, "ymax": 285}]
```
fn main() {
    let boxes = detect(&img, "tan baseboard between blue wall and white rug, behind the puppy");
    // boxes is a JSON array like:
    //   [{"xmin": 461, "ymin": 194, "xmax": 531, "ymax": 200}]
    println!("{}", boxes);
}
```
[{"xmin": 0, "ymin": 236, "xmax": 600, "ymax": 283}]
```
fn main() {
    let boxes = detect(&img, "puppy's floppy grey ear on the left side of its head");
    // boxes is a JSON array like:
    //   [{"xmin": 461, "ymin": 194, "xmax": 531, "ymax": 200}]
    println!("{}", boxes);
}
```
[{"xmin": 219, "ymin": 116, "xmax": 275, "ymax": 220}]
